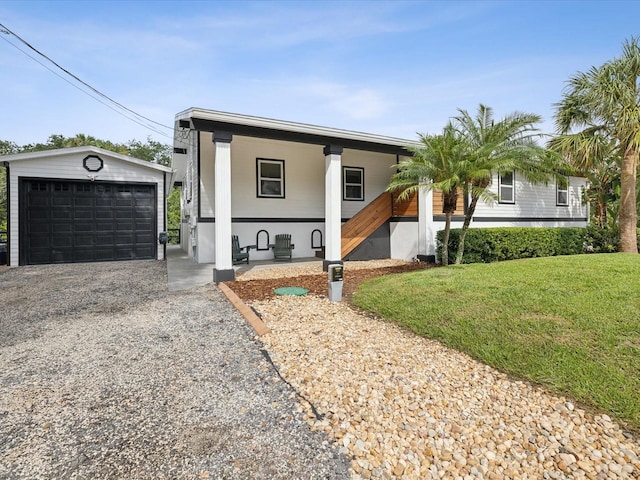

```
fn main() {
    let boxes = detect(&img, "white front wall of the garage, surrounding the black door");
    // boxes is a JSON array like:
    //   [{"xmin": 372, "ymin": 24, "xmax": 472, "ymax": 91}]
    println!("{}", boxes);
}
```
[{"xmin": 7, "ymin": 152, "xmax": 165, "ymax": 265}]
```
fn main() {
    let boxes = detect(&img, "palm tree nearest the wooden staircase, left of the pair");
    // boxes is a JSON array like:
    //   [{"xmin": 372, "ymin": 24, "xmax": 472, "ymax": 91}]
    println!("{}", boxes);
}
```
[{"xmin": 387, "ymin": 123, "xmax": 468, "ymax": 265}]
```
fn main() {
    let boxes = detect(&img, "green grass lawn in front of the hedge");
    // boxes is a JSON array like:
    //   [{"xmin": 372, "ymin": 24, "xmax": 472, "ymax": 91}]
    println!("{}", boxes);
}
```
[{"xmin": 354, "ymin": 254, "xmax": 640, "ymax": 431}]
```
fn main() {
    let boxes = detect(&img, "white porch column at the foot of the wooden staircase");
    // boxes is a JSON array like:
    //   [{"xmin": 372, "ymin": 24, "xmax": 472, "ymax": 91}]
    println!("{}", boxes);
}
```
[{"xmin": 322, "ymin": 145, "xmax": 342, "ymax": 272}]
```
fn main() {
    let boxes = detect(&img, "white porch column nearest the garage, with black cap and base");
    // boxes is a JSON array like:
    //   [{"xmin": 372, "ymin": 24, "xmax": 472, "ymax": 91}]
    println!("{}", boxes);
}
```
[{"xmin": 212, "ymin": 132, "xmax": 236, "ymax": 283}]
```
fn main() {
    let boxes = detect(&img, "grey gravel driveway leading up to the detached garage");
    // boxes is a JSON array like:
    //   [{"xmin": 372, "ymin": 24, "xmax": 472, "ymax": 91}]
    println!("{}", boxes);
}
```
[{"xmin": 0, "ymin": 261, "xmax": 349, "ymax": 479}]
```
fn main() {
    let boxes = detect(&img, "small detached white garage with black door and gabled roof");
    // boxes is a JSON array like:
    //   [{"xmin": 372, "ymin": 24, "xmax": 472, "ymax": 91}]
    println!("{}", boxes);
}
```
[{"xmin": 0, "ymin": 147, "xmax": 172, "ymax": 265}]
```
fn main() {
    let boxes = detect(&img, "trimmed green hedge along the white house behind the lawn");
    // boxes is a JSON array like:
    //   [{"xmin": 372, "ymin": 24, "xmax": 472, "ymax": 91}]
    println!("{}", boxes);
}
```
[{"xmin": 437, "ymin": 227, "xmax": 587, "ymax": 263}]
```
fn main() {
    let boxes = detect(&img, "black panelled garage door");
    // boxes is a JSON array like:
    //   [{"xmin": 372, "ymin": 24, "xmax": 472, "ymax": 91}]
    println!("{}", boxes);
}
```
[{"xmin": 20, "ymin": 179, "xmax": 157, "ymax": 265}]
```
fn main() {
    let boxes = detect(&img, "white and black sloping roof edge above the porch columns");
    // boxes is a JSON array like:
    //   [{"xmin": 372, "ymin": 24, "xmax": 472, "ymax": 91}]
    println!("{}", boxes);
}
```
[{"xmin": 176, "ymin": 107, "xmax": 418, "ymax": 155}]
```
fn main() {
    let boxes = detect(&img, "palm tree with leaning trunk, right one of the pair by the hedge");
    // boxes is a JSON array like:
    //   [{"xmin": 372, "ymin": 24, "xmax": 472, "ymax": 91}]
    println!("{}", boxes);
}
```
[{"xmin": 454, "ymin": 104, "xmax": 557, "ymax": 264}]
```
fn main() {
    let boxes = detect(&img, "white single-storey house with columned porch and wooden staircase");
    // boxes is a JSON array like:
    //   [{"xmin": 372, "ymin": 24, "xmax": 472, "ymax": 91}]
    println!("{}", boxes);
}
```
[{"xmin": 173, "ymin": 108, "xmax": 588, "ymax": 282}]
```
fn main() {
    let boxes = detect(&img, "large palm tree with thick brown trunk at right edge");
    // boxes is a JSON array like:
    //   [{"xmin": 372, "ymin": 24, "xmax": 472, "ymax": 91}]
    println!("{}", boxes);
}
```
[{"xmin": 556, "ymin": 37, "xmax": 640, "ymax": 253}]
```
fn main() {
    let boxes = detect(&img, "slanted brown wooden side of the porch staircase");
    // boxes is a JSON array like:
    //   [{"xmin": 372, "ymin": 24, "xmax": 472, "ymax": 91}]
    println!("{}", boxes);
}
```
[{"xmin": 341, "ymin": 192, "xmax": 393, "ymax": 258}]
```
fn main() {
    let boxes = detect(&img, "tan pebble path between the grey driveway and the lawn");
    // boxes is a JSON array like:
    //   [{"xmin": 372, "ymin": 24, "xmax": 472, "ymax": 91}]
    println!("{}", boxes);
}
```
[{"xmin": 251, "ymin": 292, "xmax": 640, "ymax": 480}]
